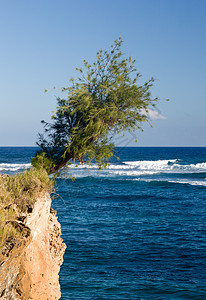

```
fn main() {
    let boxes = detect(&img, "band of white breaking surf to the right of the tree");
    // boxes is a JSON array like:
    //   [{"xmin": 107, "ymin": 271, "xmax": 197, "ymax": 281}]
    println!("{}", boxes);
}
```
[{"xmin": 68, "ymin": 159, "xmax": 206, "ymax": 186}]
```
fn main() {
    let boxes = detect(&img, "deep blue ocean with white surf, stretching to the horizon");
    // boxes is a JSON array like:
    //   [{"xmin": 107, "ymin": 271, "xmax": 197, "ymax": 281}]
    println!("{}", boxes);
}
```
[{"xmin": 0, "ymin": 147, "xmax": 206, "ymax": 300}]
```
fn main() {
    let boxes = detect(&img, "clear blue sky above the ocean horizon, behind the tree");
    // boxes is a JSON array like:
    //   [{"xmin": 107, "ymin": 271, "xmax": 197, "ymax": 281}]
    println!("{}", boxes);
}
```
[{"xmin": 0, "ymin": 0, "xmax": 206, "ymax": 146}]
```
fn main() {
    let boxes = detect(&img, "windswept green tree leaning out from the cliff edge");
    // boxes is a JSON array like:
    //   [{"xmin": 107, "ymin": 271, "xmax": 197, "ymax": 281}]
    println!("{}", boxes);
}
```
[{"xmin": 32, "ymin": 38, "xmax": 161, "ymax": 174}]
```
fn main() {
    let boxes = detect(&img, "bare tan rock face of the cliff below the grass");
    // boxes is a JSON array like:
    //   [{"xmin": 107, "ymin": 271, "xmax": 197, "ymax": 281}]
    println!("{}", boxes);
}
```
[{"xmin": 0, "ymin": 195, "xmax": 66, "ymax": 300}]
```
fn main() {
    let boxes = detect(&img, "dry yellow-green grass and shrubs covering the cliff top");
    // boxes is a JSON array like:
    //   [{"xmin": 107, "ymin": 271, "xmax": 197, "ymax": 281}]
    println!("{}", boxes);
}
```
[{"xmin": 0, "ymin": 169, "xmax": 53, "ymax": 247}]
